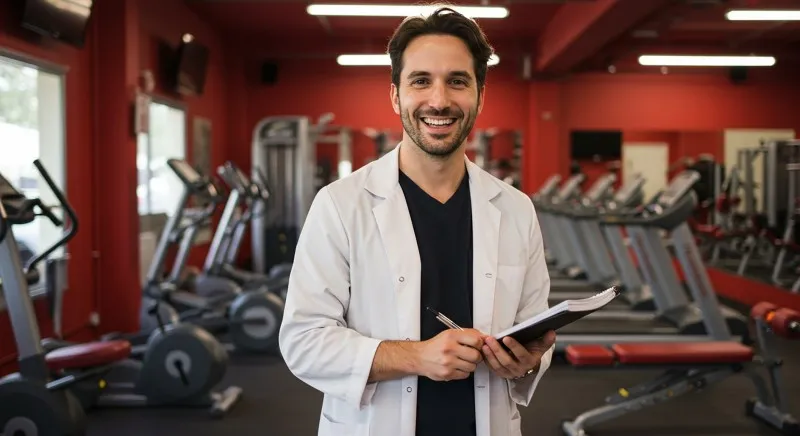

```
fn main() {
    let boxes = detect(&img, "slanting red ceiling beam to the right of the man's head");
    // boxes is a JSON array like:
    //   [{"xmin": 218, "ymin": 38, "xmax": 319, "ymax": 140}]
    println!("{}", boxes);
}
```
[{"xmin": 536, "ymin": 0, "xmax": 674, "ymax": 74}]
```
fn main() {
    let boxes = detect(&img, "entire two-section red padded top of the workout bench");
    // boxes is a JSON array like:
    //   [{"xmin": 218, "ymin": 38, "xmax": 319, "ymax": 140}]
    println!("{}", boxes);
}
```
[{"xmin": 566, "ymin": 341, "xmax": 754, "ymax": 366}]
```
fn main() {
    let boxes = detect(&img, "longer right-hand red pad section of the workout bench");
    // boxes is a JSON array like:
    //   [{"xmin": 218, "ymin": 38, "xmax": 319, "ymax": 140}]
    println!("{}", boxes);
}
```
[{"xmin": 611, "ymin": 342, "xmax": 754, "ymax": 365}]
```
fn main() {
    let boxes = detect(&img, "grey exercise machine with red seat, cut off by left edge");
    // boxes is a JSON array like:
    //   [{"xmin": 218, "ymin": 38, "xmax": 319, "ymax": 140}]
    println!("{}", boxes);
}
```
[{"xmin": 0, "ymin": 161, "xmax": 130, "ymax": 436}]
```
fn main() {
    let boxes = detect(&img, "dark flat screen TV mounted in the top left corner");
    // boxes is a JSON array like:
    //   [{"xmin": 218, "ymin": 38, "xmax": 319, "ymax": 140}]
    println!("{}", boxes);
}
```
[{"xmin": 22, "ymin": 0, "xmax": 94, "ymax": 48}]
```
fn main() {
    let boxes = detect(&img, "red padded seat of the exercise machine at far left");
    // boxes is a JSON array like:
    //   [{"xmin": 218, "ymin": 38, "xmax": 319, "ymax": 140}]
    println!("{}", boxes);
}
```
[{"xmin": 45, "ymin": 341, "xmax": 131, "ymax": 371}]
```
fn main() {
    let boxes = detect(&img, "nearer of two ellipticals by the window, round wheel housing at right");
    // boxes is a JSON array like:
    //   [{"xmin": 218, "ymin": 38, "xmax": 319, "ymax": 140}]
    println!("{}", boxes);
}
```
[{"xmin": 141, "ymin": 159, "xmax": 284, "ymax": 353}]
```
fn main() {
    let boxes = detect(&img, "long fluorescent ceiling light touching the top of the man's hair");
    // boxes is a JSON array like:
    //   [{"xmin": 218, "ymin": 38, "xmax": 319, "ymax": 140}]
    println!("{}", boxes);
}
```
[{"xmin": 306, "ymin": 4, "xmax": 508, "ymax": 18}]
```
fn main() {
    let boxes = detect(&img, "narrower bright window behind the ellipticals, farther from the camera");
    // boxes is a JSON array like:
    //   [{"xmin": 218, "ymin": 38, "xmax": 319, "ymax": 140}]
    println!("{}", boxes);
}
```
[{"xmin": 136, "ymin": 101, "xmax": 186, "ymax": 216}]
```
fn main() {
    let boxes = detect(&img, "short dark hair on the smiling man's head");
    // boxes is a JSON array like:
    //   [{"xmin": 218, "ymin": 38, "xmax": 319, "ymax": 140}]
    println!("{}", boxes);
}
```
[{"xmin": 388, "ymin": 7, "xmax": 494, "ymax": 89}]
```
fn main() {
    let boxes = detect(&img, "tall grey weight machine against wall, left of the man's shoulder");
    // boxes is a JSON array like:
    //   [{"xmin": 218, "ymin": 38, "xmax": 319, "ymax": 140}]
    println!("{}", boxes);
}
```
[{"xmin": 251, "ymin": 113, "xmax": 353, "ymax": 274}]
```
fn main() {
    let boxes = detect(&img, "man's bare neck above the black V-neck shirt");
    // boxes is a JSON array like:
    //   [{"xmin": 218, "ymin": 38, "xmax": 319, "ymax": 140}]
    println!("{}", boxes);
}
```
[{"xmin": 399, "ymin": 139, "xmax": 466, "ymax": 203}]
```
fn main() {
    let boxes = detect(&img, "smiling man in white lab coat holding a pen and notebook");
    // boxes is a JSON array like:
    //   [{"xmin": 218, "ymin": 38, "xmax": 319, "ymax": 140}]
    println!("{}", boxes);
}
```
[{"xmin": 280, "ymin": 8, "xmax": 555, "ymax": 436}]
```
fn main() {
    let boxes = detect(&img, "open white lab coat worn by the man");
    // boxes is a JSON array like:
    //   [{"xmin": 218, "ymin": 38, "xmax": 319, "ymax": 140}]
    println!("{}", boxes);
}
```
[{"xmin": 280, "ymin": 146, "xmax": 552, "ymax": 436}]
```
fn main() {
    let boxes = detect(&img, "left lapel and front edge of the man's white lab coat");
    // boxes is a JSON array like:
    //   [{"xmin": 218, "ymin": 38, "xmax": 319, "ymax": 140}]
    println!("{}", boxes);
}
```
[{"xmin": 366, "ymin": 146, "xmax": 421, "ymax": 341}]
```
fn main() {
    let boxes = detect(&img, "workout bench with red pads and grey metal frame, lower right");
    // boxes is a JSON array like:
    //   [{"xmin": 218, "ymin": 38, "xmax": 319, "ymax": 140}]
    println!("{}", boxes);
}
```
[{"xmin": 562, "ymin": 302, "xmax": 800, "ymax": 436}]
